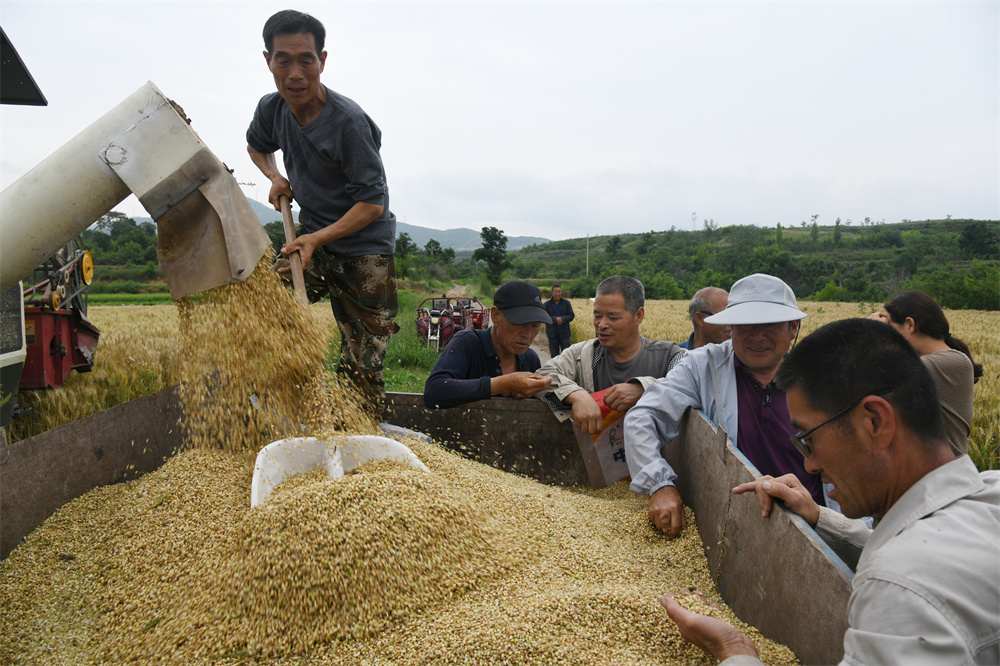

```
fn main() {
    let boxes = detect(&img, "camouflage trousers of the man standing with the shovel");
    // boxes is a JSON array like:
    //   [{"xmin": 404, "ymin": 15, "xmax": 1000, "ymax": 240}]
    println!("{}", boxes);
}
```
[{"xmin": 275, "ymin": 247, "xmax": 399, "ymax": 420}]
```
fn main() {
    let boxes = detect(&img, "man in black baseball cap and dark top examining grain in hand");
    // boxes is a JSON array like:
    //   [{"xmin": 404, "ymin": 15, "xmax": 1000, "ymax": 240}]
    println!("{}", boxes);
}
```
[{"xmin": 424, "ymin": 280, "xmax": 552, "ymax": 408}]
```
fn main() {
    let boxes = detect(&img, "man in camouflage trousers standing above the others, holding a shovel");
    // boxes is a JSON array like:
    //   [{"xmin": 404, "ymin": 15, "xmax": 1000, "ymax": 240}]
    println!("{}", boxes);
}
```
[{"xmin": 247, "ymin": 10, "xmax": 399, "ymax": 416}]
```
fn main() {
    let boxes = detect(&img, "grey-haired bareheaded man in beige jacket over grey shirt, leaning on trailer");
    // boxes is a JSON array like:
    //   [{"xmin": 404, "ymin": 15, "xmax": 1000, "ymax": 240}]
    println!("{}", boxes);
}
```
[{"xmin": 538, "ymin": 275, "xmax": 684, "ymax": 434}]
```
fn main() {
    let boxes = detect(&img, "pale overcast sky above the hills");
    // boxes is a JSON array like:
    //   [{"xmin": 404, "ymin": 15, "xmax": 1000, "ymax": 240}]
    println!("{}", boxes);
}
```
[{"xmin": 0, "ymin": 0, "xmax": 1000, "ymax": 239}]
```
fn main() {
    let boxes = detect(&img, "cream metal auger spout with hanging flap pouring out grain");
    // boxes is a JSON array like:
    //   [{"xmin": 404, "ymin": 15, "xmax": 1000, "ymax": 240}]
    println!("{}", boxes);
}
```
[{"xmin": 0, "ymin": 82, "xmax": 270, "ymax": 300}]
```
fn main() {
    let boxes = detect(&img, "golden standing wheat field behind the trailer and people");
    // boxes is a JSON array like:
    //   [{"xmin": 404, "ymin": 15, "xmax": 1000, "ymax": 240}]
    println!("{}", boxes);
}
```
[{"xmin": 10, "ymin": 299, "xmax": 1000, "ymax": 469}]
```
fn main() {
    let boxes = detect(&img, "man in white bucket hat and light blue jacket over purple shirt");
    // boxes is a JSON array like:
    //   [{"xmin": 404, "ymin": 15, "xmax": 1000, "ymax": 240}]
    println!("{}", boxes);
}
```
[{"xmin": 625, "ymin": 273, "xmax": 824, "ymax": 536}]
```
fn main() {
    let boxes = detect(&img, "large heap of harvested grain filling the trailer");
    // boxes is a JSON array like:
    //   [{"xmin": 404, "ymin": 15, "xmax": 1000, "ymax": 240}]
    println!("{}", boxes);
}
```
[{"xmin": 0, "ymin": 440, "xmax": 794, "ymax": 664}]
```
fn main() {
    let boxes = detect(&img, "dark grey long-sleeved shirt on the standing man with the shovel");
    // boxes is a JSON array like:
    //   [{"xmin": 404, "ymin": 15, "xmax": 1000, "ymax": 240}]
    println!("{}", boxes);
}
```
[{"xmin": 247, "ymin": 88, "xmax": 396, "ymax": 257}]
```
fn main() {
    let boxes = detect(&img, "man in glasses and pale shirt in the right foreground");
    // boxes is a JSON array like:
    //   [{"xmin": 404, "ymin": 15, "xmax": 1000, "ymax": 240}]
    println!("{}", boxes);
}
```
[{"xmin": 660, "ymin": 319, "xmax": 1000, "ymax": 666}]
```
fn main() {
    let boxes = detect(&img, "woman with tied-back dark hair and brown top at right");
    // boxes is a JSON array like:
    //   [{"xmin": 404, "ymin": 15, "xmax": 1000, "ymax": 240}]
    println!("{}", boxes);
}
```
[{"xmin": 871, "ymin": 291, "xmax": 983, "ymax": 455}]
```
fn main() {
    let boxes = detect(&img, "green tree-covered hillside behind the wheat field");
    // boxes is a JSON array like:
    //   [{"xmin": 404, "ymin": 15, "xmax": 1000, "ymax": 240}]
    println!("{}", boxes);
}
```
[{"xmin": 83, "ymin": 212, "xmax": 1000, "ymax": 310}]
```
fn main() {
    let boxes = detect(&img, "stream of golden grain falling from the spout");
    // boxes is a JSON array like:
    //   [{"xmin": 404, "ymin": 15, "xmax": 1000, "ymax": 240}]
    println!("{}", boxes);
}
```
[{"xmin": 178, "ymin": 251, "xmax": 378, "ymax": 452}]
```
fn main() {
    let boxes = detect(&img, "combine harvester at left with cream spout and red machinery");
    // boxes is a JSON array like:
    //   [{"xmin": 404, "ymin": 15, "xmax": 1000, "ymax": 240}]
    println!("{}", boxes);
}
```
[{"xmin": 0, "ymin": 78, "xmax": 270, "ymax": 427}]
